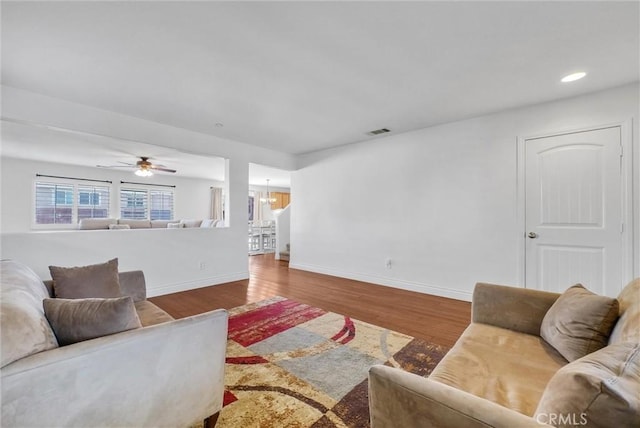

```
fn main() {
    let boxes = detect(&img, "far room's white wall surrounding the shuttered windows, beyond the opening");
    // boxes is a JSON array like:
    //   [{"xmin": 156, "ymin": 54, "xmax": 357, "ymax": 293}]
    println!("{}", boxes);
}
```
[{"xmin": 0, "ymin": 157, "xmax": 224, "ymax": 233}]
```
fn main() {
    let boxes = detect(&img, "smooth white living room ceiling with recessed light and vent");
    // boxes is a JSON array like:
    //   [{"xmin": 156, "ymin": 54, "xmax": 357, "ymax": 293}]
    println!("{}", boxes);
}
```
[{"xmin": 2, "ymin": 1, "xmax": 640, "ymax": 154}]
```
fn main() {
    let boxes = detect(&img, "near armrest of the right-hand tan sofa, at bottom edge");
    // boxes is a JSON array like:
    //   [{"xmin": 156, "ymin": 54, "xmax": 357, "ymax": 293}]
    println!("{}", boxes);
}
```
[{"xmin": 369, "ymin": 365, "xmax": 549, "ymax": 428}]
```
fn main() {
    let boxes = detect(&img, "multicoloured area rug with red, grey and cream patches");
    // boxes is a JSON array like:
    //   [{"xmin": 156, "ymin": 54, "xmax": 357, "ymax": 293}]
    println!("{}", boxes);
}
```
[{"xmin": 217, "ymin": 297, "xmax": 448, "ymax": 428}]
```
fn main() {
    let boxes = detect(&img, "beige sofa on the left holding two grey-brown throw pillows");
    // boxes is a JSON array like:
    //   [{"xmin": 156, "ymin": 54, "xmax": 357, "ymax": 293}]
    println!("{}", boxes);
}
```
[{"xmin": 0, "ymin": 260, "xmax": 227, "ymax": 428}]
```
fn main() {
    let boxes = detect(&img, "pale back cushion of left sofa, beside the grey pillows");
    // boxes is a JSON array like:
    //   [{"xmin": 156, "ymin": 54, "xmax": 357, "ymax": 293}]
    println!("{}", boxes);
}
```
[{"xmin": 0, "ymin": 260, "xmax": 58, "ymax": 367}]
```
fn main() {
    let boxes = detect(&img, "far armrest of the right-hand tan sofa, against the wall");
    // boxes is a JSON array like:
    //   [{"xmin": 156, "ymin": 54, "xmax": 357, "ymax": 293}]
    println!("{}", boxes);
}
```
[{"xmin": 471, "ymin": 282, "xmax": 560, "ymax": 336}]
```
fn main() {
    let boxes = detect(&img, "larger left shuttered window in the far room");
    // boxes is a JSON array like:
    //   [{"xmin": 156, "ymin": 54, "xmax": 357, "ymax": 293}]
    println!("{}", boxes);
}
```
[{"xmin": 35, "ymin": 181, "xmax": 109, "ymax": 225}]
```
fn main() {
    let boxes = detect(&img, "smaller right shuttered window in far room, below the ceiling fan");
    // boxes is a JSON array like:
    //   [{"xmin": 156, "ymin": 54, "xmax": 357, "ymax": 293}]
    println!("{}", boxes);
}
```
[{"xmin": 120, "ymin": 189, "xmax": 173, "ymax": 220}]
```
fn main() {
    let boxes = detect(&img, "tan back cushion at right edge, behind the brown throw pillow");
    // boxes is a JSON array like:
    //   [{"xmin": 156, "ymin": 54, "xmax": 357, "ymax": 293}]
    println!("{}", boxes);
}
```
[{"xmin": 609, "ymin": 278, "xmax": 640, "ymax": 344}]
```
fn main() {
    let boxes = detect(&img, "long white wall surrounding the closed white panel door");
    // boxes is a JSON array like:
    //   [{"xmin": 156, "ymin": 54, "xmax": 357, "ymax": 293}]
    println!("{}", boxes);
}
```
[{"xmin": 290, "ymin": 84, "xmax": 640, "ymax": 300}]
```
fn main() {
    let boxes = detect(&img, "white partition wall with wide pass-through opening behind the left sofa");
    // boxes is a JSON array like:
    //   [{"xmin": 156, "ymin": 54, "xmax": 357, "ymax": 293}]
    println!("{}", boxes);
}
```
[{"xmin": 0, "ymin": 86, "xmax": 295, "ymax": 295}]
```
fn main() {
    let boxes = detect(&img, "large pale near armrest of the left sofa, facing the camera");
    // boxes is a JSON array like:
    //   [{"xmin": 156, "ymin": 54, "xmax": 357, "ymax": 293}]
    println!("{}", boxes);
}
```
[{"xmin": 0, "ymin": 309, "xmax": 227, "ymax": 427}]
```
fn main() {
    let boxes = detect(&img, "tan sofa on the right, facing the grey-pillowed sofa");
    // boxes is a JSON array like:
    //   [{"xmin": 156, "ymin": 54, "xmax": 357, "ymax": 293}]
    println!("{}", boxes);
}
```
[{"xmin": 369, "ymin": 279, "xmax": 640, "ymax": 428}]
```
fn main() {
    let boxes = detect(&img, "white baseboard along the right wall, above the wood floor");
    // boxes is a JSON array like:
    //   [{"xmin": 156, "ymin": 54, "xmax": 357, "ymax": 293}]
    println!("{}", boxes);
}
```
[{"xmin": 289, "ymin": 263, "xmax": 473, "ymax": 302}]
